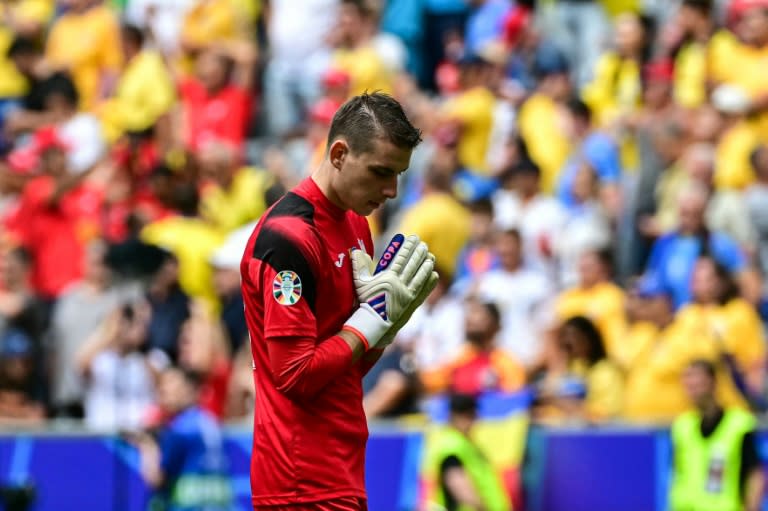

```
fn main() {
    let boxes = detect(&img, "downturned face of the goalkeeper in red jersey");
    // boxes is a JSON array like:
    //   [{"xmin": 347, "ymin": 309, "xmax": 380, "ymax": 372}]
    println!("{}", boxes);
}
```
[{"xmin": 330, "ymin": 139, "xmax": 412, "ymax": 216}]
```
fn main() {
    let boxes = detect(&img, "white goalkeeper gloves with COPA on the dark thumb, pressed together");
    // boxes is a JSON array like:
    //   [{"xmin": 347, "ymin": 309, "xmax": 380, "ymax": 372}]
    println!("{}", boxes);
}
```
[{"xmin": 343, "ymin": 234, "xmax": 437, "ymax": 350}]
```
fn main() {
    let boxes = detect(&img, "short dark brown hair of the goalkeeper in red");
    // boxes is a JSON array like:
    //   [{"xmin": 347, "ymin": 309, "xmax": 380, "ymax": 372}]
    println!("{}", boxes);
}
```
[{"xmin": 328, "ymin": 92, "xmax": 421, "ymax": 153}]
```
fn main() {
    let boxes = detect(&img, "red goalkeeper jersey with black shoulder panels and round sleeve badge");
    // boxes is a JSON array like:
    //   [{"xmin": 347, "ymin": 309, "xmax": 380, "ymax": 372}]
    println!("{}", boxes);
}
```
[{"xmin": 241, "ymin": 178, "xmax": 373, "ymax": 506}]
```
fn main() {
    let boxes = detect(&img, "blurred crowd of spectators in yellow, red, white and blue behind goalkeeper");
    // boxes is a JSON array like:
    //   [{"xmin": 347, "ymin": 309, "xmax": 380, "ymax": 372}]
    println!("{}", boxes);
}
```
[{"xmin": 0, "ymin": 0, "xmax": 768, "ymax": 431}]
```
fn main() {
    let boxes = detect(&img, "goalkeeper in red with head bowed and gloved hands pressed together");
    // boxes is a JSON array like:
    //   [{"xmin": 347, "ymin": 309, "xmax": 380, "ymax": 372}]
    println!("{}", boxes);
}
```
[{"xmin": 241, "ymin": 93, "xmax": 437, "ymax": 511}]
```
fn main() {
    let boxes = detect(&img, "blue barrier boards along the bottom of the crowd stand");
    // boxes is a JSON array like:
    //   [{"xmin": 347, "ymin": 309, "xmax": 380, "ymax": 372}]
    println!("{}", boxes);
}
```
[{"xmin": 0, "ymin": 400, "xmax": 768, "ymax": 511}]
